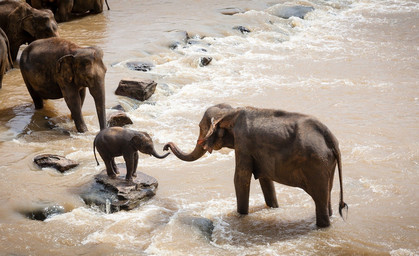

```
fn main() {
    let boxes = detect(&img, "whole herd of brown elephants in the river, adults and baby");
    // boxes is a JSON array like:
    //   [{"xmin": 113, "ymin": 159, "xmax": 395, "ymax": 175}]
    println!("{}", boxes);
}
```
[{"xmin": 0, "ymin": 0, "xmax": 348, "ymax": 227}]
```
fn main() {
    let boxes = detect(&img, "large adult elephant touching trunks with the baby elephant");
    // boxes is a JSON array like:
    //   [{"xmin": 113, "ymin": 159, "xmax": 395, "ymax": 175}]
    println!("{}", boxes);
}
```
[{"xmin": 164, "ymin": 104, "xmax": 347, "ymax": 227}]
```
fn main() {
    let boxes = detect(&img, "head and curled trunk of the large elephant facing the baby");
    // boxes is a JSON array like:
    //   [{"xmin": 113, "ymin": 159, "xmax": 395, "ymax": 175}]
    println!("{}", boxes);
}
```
[{"xmin": 163, "ymin": 104, "xmax": 240, "ymax": 161}]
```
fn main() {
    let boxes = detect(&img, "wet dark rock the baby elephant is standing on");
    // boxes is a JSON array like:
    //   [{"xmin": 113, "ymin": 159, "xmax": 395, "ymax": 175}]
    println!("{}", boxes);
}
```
[{"xmin": 81, "ymin": 164, "xmax": 158, "ymax": 213}]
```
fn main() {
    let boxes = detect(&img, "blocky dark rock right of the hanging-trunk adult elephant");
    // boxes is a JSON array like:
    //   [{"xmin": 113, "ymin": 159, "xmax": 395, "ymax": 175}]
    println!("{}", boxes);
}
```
[{"xmin": 115, "ymin": 80, "xmax": 157, "ymax": 101}]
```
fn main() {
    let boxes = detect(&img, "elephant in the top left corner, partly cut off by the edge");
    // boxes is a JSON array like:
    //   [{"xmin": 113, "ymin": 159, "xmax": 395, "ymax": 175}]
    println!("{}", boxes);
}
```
[{"xmin": 0, "ymin": 0, "xmax": 58, "ymax": 61}]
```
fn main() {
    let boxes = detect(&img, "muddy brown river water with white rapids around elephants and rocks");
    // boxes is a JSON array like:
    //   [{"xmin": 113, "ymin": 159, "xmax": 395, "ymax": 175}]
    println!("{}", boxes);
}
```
[{"xmin": 0, "ymin": 0, "xmax": 419, "ymax": 255}]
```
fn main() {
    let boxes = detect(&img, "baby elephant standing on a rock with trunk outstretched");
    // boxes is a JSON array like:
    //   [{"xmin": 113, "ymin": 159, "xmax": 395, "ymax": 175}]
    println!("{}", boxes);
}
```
[{"xmin": 93, "ymin": 127, "xmax": 169, "ymax": 181}]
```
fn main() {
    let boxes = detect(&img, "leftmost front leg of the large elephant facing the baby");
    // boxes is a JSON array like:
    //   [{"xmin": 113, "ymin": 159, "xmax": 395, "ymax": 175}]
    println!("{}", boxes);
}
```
[{"xmin": 234, "ymin": 151, "xmax": 252, "ymax": 214}]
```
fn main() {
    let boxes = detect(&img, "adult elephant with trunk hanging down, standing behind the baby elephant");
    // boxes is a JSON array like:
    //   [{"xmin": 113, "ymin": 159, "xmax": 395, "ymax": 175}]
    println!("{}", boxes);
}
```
[{"xmin": 20, "ymin": 38, "xmax": 106, "ymax": 132}]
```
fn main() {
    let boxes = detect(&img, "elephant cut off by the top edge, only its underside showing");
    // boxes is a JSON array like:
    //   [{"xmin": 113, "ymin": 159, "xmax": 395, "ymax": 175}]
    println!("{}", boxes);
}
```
[{"xmin": 26, "ymin": 0, "xmax": 110, "ymax": 22}]
